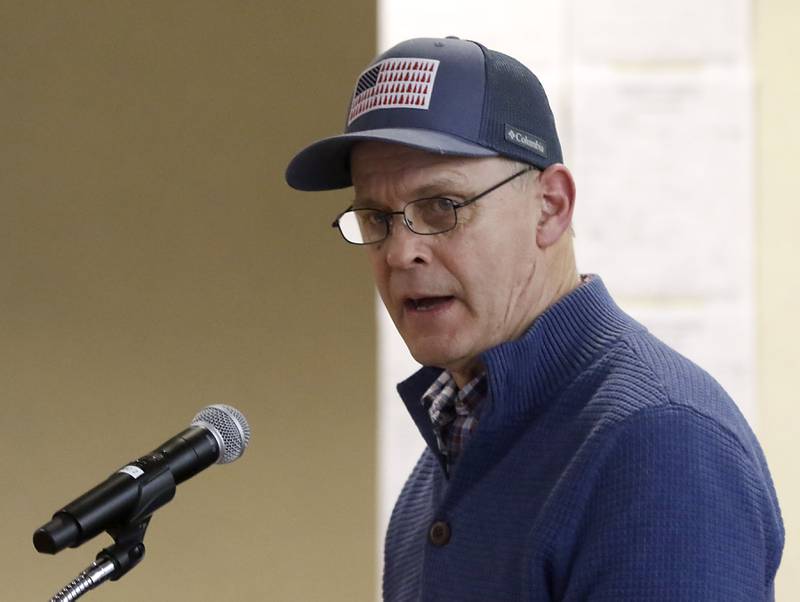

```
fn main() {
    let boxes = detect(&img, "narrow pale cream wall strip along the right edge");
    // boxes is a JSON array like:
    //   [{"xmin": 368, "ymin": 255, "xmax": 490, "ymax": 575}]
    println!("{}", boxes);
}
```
[{"xmin": 755, "ymin": 0, "xmax": 800, "ymax": 600}]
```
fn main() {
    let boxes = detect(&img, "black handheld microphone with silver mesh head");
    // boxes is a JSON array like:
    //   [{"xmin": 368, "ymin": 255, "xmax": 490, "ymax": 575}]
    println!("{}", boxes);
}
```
[{"xmin": 33, "ymin": 404, "xmax": 250, "ymax": 554}]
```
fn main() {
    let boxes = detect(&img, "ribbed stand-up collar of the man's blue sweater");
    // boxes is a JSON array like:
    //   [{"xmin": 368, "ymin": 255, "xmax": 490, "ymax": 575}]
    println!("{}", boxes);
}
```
[{"xmin": 397, "ymin": 276, "xmax": 641, "ymax": 450}]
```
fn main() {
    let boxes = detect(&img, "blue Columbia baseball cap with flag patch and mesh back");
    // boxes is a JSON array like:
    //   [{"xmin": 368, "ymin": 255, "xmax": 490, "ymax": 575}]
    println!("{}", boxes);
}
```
[{"xmin": 286, "ymin": 38, "xmax": 562, "ymax": 190}]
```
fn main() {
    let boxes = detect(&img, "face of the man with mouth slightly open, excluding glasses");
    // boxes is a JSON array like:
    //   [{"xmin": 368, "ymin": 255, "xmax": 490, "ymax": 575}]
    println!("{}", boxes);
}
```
[{"xmin": 351, "ymin": 142, "xmax": 542, "ymax": 376}]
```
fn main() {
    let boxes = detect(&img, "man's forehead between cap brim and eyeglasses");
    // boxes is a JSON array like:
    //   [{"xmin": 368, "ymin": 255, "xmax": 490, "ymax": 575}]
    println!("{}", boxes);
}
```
[{"xmin": 350, "ymin": 142, "xmax": 507, "ymax": 196}]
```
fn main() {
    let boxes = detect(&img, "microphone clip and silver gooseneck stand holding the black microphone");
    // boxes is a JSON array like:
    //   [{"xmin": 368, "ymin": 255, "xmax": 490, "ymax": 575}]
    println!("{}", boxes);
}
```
[{"xmin": 50, "ymin": 468, "xmax": 175, "ymax": 602}]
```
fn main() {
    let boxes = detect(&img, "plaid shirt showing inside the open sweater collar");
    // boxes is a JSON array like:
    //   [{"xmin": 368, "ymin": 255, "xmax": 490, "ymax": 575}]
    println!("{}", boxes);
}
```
[{"xmin": 422, "ymin": 370, "xmax": 486, "ymax": 474}]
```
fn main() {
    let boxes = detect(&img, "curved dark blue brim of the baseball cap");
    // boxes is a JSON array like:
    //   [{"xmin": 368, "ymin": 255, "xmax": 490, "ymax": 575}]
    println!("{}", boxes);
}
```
[{"xmin": 286, "ymin": 128, "xmax": 498, "ymax": 190}]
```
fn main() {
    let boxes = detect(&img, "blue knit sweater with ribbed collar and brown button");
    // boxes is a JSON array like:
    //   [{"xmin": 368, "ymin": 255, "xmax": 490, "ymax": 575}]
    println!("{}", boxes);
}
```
[{"xmin": 383, "ymin": 277, "xmax": 784, "ymax": 602}]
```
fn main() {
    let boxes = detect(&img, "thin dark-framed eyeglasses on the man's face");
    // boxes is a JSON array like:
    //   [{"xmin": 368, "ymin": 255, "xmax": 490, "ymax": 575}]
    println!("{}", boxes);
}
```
[{"xmin": 331, "ymin": 165, "xmax": 536, "ymax": 245}]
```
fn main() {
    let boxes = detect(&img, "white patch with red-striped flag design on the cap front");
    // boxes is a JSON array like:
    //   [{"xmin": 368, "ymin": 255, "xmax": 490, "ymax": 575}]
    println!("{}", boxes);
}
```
[{"xmin": 347, "ymin": 58, "xmax": 439, "ymax": 126}]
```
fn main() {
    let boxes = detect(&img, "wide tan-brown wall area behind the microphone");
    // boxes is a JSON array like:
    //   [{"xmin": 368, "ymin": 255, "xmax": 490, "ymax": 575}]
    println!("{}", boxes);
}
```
[{"xmin": 0, "ymin": 0, "xmax": 375, "ymax": 602}]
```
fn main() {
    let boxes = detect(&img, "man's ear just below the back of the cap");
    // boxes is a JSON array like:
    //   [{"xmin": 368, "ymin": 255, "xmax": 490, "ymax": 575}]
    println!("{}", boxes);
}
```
[{"xmin": 536, "ymin": 163, "xmax": 575, "ymax": 249}]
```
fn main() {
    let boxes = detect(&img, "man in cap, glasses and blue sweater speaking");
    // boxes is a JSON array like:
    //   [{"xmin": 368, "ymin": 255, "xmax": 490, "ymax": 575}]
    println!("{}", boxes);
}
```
[{"xmin": 287, "ymin": 38, "xmax": 783, "ymax": 602}]
